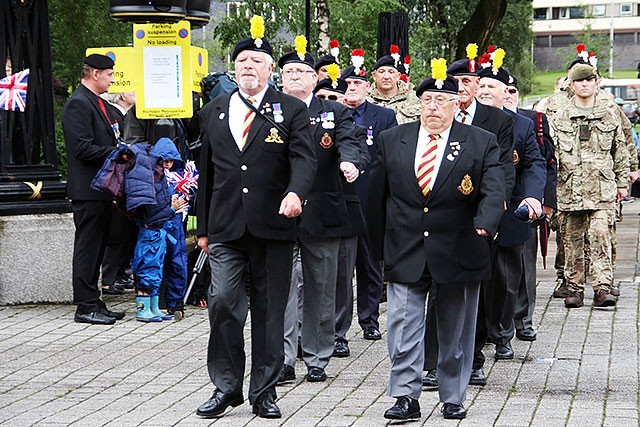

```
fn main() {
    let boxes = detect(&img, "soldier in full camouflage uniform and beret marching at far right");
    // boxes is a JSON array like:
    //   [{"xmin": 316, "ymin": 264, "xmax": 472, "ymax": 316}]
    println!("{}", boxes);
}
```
[{"xmin": 550, "ymin": 64, "xmax": 629, "ymax": 308}]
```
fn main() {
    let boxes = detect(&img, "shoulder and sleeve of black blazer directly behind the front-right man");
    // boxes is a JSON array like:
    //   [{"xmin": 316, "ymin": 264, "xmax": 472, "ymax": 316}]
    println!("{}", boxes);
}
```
[{"xmin": 471, "ymin": 100, "xmax": 516, "ymax": 203}]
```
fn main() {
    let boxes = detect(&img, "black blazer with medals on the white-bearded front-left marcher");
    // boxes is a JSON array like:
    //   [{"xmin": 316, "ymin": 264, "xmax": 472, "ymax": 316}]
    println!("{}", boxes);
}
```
[{"xmin": 196, "ymin": 88, "xmax": 316, "ymax": 243}]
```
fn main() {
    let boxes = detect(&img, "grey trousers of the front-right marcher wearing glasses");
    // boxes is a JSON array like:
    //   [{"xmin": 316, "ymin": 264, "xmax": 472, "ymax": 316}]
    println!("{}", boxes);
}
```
[{"xmin": 387, "ymin": 278, "xmax": 480, "ymax": 404}]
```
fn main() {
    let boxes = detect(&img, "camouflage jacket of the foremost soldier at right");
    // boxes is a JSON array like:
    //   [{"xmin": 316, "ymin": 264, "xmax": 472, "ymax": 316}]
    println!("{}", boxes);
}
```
[{"xmin": 549, "ymin": 98, "xmax": 629, "ymax": 211}]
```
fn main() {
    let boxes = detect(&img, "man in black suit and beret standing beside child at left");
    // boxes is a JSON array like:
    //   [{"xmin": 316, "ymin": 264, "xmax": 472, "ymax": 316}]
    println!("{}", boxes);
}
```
[{"xmin": 62, "ymin": 54, "xmax": 124, "ymax": 325}]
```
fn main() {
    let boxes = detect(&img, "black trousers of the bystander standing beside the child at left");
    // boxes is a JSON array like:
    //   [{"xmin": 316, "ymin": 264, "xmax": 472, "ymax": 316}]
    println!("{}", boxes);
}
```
[{"xmin": 71, "ymin": 200, "xmax": 112, "ymax": 314}]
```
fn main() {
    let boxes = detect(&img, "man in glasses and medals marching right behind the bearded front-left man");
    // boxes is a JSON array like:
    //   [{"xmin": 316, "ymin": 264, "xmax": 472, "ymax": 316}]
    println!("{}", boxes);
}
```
[{"xmin": 278, "ymin": 43, "xmax": 360, "ymax": 382}]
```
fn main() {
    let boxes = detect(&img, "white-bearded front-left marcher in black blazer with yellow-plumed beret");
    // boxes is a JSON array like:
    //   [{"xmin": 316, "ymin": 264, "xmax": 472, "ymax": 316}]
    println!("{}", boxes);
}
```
[{"xmin": 196, "ymin": 23, "xmax": 316, "ymax": 418}]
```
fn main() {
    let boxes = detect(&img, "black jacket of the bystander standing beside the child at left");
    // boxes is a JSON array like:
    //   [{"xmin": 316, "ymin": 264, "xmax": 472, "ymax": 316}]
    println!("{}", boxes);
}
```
[{"xmin": 61, "ymin": 84, "xmax": 122, "ymax": 200}]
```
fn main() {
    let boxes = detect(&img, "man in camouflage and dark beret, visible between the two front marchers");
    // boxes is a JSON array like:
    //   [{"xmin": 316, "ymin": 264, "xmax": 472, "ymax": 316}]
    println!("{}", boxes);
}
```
[{"xmin": 367, "ymin": 50, "xmax": 420, "ymax": 125}]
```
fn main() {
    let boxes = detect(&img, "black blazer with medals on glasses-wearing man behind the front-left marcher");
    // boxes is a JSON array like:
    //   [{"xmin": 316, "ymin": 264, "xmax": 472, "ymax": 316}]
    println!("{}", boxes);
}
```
[{"xmin": 301, "ymin": 96, "xmax": 360, "ymax": 237}]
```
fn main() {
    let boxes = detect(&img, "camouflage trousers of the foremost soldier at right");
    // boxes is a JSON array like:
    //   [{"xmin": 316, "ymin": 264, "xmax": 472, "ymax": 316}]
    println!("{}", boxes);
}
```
[{"xmin": 558, "ymin": 209, "xmax": 616, "ymax": 292}]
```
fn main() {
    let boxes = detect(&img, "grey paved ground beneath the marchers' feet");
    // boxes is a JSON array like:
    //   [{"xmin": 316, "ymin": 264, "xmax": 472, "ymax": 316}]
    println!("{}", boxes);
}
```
[{"xmin": 0, "ymin": 201, "xmax": 640, "ymax": 427}]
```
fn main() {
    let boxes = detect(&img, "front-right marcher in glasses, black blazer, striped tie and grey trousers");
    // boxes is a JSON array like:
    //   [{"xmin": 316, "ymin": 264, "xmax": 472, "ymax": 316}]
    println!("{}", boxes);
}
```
[{"xmin": 367, "ymin": 64, "xmax": 505, "ymax": 420}]
